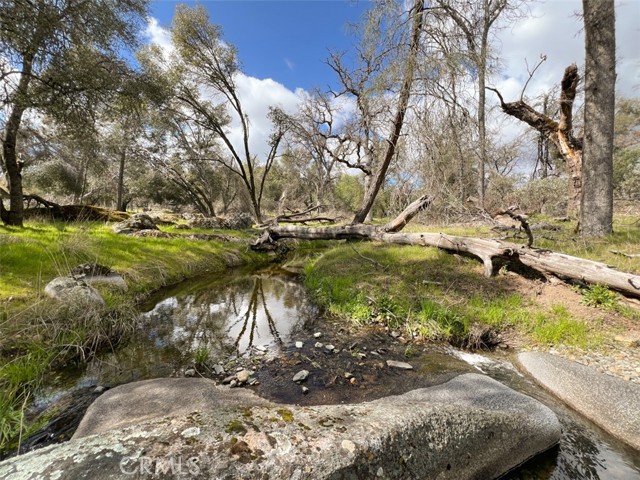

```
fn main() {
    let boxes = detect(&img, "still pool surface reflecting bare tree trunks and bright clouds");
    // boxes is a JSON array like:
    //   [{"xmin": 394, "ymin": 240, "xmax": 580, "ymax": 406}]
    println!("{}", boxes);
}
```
[{"xmin": 80, "ymin": 272, "xmax": 316, "ymax": 385}]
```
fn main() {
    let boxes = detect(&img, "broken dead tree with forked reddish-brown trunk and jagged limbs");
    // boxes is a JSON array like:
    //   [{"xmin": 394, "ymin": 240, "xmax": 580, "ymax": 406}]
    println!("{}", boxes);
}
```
[{"xmin": 487, "ymin": 64, "xmax": 582, "ymax": 215}]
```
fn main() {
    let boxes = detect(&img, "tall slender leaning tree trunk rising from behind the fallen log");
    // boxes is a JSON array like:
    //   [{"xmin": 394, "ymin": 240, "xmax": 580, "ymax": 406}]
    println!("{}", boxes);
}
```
[{"xmin": 351, "ymin": 0, "xmax": 424, "ymax": 224}]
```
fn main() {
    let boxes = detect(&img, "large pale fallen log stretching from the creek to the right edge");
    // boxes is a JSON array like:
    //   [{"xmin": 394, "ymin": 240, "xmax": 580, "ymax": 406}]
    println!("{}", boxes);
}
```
[{"xmin": 252, "ymin": 224, "xmax": 640, "ymax": 297}]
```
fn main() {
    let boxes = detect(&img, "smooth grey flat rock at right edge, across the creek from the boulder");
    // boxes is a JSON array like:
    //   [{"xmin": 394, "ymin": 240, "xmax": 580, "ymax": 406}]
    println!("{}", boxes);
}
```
[{"xmin": 518, "ymin": 352, "xmax": 640, "ymax": 450}]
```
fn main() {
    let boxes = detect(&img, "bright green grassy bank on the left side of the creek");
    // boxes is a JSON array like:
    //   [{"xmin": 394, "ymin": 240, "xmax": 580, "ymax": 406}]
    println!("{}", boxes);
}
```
[{"xmin": 0, "ymin": 222, "xmax": 265, "ymax": 448}]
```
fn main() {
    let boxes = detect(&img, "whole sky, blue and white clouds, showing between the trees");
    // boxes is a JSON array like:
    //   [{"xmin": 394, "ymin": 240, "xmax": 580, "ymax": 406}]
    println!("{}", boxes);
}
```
[{"xmin": 146, "ymin": 0, "xmax": 640, "ymax": 161}]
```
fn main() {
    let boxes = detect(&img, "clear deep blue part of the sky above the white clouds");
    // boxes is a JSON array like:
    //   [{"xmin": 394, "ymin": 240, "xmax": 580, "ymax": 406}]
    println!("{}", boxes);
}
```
[{"xmin": 151, "ymin": 0, "xmax": 370, "ymax": 90}]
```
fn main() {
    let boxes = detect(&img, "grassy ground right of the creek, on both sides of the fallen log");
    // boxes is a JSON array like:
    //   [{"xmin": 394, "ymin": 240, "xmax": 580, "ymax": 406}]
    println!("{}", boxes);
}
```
[{"xmin": 306, "ymin": 219, "xmax": 640, "ymax": 348}]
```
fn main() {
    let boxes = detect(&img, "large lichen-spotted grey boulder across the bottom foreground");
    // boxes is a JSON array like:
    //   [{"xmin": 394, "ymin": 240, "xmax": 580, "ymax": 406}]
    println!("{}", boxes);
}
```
[{"xmin": 0, "ymin": 374, "xmax": 560, "ymax": 479}]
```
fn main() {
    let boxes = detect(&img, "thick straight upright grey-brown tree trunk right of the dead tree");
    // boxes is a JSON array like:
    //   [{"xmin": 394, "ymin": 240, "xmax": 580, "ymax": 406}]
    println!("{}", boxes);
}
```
[{"xmin": 580, "ymin": 0, "xmax": 616, "ymax": 236}]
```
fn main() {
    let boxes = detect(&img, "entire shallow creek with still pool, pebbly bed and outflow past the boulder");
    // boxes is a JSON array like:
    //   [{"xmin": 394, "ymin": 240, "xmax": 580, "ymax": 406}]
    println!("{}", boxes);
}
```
[{"xmin": 15, "ymin": 270, "xmax": 640, "ymax": 480}]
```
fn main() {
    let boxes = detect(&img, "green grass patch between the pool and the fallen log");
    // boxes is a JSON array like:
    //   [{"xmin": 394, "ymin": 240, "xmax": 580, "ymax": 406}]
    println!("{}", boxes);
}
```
[{"xmin": 305, "ymin": 243, "xmax": 616, "ymax": 347}]
